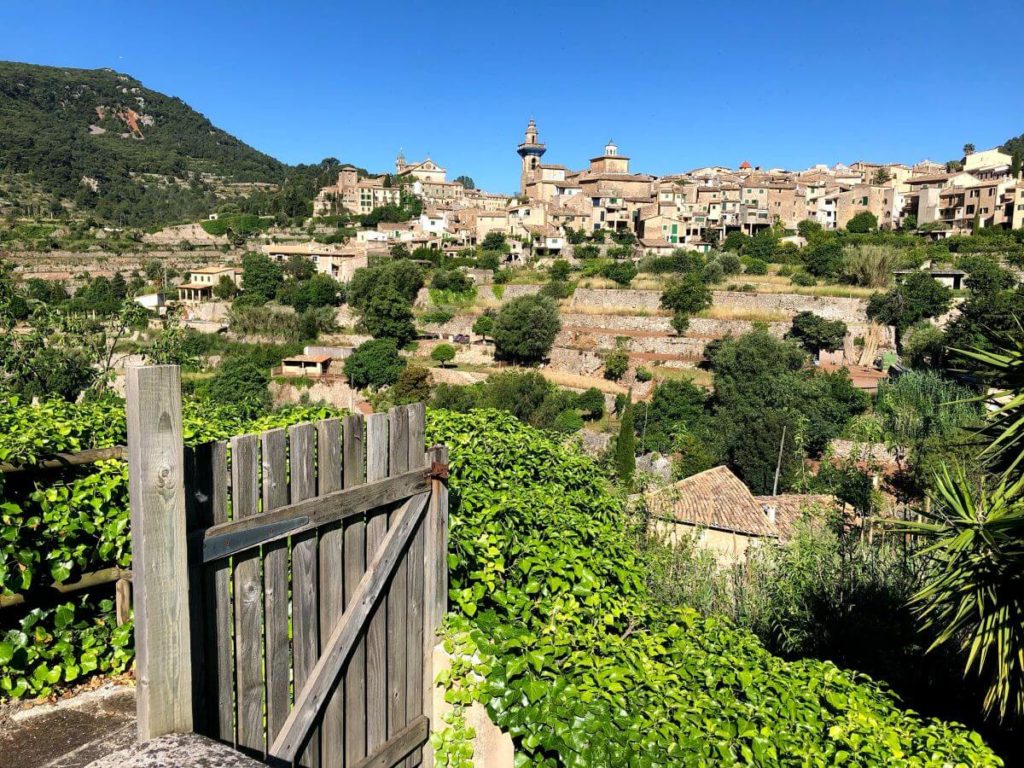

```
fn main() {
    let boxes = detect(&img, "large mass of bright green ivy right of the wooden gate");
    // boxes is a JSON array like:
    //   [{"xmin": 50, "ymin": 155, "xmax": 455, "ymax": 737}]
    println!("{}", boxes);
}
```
[{"xmin": 427, "ymin": 412, "xmax": 999, "ymax": 767}]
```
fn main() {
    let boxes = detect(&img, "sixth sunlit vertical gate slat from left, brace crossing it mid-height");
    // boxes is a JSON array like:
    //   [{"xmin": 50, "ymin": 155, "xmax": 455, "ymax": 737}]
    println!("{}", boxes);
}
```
[{"xmin": 335, "ymin": 414, "xmax": 367, "ymax": 765}]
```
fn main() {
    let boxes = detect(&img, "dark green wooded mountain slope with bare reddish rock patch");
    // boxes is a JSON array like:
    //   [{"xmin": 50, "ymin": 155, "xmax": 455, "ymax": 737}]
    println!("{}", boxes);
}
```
[{"xmin": 0, "ymin": 61, "xmax": 288, "ymax": 223}]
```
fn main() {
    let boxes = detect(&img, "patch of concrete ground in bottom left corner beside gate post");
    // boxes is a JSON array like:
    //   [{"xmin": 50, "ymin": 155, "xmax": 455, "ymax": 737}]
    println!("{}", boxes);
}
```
[{"xmin": 0, "ymin": 684, "xmax": 135, "ymax": 768}]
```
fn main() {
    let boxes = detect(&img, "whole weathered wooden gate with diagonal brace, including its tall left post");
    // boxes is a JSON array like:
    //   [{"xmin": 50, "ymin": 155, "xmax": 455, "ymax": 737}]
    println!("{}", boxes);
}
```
[{"xmin": 127, "ymin": 366, "xmax": 447, "ymax": 768}]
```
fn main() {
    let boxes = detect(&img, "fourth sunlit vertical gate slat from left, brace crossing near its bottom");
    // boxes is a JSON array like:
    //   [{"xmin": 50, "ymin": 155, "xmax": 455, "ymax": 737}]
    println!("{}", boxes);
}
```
[{"xmin": 285, "ymin": 424, "xmax": 319, "ymax": 768}]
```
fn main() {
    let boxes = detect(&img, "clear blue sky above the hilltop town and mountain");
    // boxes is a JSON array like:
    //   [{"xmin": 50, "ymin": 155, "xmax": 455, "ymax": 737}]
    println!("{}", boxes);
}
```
[{"xmin": 0, "ymin": 0, "xmax": 1024, "ymax": 191}]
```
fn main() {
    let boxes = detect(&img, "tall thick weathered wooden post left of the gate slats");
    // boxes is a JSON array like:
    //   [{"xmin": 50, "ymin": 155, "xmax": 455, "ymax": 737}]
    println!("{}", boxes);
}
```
[{"xmin": 126, "ymin": 366, "xmax": 193, "ymax": 740}]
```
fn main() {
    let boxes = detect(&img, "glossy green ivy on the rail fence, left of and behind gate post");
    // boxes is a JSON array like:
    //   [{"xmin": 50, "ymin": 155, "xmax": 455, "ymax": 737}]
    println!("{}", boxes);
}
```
[{"xmin": 0, "ymin": 396, "xmax": 339, "ymax": 698}]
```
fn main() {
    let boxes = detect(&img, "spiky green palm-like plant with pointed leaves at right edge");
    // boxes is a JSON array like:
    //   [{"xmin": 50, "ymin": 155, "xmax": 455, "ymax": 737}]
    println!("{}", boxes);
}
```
[{"xmin": 894, "ymin": 322, "xmax": 1024, "ymax": 718}]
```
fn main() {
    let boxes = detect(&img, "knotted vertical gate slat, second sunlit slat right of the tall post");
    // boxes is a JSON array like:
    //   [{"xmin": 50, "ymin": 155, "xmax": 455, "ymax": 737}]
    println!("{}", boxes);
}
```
[{"xmin": 231, "ymin": 435, "xmax": 266, "ymax": 756}]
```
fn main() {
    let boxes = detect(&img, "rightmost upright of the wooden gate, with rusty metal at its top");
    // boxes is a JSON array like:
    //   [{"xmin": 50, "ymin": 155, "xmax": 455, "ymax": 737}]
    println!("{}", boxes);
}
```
[{"xmin": 423, "ymin": 445, "xmax": 447, "ymax": 768}]
